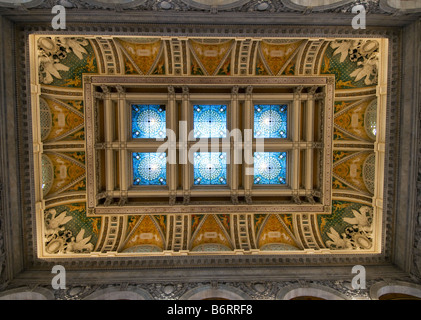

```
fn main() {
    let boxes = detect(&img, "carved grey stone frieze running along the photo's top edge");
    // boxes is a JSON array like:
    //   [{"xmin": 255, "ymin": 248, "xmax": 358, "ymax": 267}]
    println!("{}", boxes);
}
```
[{"xmin": 1, "ymin": 0, "xmax": 419, "ymax": 15}]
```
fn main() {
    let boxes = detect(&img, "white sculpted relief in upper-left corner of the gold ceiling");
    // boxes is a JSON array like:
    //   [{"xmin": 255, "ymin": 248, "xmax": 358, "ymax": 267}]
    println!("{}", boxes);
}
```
[{"xmin": 38, "ymin": 37, "xmax": 89, "ymax": 84}]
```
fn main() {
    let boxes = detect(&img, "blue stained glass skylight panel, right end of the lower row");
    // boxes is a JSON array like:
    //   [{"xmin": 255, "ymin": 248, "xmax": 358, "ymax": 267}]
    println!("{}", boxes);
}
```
[{"xmin": 254, "ymin": 152, "xmax": 287, "ymax": 184}]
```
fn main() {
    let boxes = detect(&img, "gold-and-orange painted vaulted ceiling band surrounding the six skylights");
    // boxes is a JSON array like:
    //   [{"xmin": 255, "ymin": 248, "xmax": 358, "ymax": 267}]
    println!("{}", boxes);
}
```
[{"xmin": 30, "ymin": 35, "xmax": 387, "ymax": 258}]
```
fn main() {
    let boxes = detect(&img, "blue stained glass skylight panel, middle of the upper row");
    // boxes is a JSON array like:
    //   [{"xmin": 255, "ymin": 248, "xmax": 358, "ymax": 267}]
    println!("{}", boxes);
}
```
[{"xmin": 193, "ymin": 105, "xmax": 227, "ymax": 138}]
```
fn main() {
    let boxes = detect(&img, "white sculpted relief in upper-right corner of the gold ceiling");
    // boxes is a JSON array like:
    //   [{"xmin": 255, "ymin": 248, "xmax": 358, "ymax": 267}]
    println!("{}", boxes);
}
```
[{"xmin": 330, "ymin": 40, "xmax": 379, "ymax": 86}]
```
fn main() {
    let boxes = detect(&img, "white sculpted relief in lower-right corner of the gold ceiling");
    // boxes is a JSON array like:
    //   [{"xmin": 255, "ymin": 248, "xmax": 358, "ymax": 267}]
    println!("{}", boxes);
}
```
[{"xmin": 326, "ymin": 206, "xmax": 373, "ymax": 250}]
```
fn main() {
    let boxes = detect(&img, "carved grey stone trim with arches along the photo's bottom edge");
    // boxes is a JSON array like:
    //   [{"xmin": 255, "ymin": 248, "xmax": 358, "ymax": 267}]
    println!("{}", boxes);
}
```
[{"xmin": 0, "ymin": 276, "xmax": 421, "ymax": 300}]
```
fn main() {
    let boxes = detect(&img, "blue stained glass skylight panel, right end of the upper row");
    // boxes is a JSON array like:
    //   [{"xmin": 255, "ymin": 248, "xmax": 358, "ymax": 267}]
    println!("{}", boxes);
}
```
[{"xmin": 254, "ymin": 104, "xmax": 288, "ymax": 139}]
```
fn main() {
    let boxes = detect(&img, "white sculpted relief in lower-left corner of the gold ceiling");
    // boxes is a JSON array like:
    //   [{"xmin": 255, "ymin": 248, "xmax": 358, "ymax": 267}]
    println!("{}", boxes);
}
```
[{"xmin": 45, "ymin": 209, "xmax": 94, "ymax": 254}]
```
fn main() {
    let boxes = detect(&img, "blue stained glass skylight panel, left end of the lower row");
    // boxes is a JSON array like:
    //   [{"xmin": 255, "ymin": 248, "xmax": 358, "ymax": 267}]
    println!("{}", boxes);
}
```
[{"xmin": 133, "ymin": 152, "xmax": 167, "ymax": 186}]
